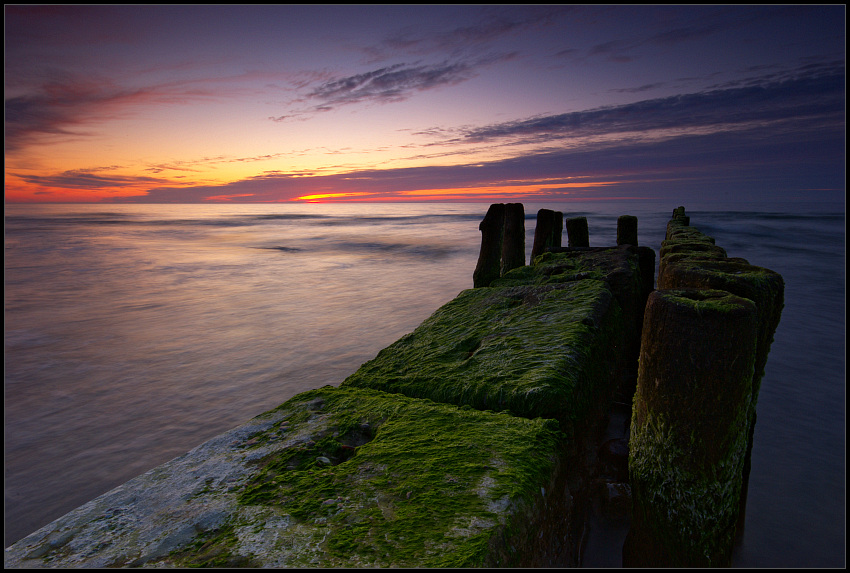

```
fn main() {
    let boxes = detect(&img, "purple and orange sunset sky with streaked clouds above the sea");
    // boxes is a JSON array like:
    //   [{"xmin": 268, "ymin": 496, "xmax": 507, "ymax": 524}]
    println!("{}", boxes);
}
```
[{"xmin": 5, "ymin": 4, "xmax": 846, "ymax": 203}]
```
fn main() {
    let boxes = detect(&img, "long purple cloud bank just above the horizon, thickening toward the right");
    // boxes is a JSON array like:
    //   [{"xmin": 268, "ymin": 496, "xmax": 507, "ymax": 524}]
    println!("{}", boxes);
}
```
[{"xmin": 111, "ymin": 109, "xmax": 844, "ymax": 202}]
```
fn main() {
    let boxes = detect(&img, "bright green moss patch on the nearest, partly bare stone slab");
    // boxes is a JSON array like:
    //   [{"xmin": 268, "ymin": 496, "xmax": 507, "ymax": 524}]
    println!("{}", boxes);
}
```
[{"xmin": 176, "ymin": 387, "xmax": 563, "ymax": 567}]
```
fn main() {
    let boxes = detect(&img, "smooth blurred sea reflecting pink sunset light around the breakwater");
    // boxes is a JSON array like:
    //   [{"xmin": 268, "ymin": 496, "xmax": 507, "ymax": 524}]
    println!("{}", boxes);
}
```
[{"xmin": 4, "ymin": 200, "xmax": 846, "ymax": 567}]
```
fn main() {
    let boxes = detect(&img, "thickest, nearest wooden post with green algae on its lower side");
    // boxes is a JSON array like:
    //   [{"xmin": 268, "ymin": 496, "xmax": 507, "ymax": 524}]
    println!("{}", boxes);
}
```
[{"xmin": 623, "ymin": 289, "xmax": 758, "ymax": 567}]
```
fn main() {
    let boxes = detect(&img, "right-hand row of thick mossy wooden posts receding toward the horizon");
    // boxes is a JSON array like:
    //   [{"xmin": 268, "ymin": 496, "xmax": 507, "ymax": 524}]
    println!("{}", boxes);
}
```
[{"xmin": 624, "ymin": 207, "xmax": 785, "ymax": 567}]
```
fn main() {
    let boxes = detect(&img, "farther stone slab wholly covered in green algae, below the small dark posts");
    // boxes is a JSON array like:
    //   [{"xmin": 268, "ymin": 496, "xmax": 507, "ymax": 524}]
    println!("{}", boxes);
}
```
[{"xmin": 342, "ymin": 278, "xmax": 623, "ymax": 431}]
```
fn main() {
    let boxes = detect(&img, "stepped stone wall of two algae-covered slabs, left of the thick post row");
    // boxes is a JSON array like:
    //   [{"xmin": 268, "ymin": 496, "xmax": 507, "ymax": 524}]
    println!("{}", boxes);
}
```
[{"xmin": 7, "ymin": 203, "xmax": 780, "ymax": 566}]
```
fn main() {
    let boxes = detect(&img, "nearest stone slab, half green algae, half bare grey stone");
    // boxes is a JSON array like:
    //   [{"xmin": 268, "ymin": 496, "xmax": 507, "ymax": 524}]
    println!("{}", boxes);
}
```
[{"xmin": 6, "ymin": 387, "xmax": 571, "ymax": 568}]
